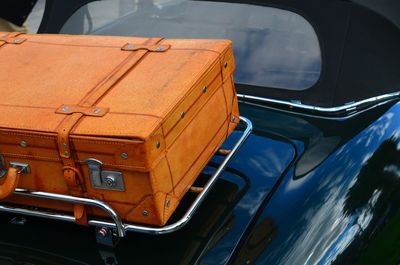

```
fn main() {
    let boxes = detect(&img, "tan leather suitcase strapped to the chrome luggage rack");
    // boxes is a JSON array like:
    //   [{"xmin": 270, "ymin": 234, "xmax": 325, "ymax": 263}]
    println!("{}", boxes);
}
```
[{"xmin": 0, "ymin": 32, "xmax": 239, "ymax": 226}]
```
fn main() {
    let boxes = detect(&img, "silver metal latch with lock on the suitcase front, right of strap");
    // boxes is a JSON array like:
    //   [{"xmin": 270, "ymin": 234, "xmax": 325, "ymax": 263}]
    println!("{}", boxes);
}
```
[{"xmin": 84, "ymin": 158, "xmax": 125, "ymax": 191}]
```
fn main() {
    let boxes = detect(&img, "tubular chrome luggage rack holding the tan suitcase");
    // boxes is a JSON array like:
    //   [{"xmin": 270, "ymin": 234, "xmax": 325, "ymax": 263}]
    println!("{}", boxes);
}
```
[{"xmin": 0, "ymin": 117, "xmax": 253, "ymax": 245}]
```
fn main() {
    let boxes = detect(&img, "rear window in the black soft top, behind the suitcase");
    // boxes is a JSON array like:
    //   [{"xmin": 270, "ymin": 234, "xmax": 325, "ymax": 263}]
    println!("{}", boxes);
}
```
[{"xmin": 61, "ymin": 0, "xmax": 321, "ymax": 91}]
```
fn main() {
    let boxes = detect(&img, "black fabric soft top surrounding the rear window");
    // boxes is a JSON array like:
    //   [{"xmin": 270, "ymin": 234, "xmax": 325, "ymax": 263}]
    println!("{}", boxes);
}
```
[{"xmin": 39, "ymin": 0, "xmax": 400, "ymax": 107}]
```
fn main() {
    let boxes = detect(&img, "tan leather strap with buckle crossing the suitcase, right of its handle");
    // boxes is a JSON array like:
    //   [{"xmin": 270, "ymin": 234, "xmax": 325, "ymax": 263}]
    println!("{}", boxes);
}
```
[{"xmin": 56, "ymin": 38, "xmax": 169, "ymax": 224}]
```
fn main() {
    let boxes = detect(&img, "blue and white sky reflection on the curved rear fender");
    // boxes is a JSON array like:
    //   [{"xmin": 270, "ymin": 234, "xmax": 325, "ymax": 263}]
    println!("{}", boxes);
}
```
[{"xmin": 238, "ymin": 103, "xmax": 400, "ymax": 264}]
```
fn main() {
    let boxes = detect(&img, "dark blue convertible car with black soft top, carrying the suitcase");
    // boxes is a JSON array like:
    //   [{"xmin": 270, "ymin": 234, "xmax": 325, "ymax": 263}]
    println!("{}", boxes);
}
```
[{"xmin": 0, "ymin": 0, "xmax": 400, "ymax": 265}]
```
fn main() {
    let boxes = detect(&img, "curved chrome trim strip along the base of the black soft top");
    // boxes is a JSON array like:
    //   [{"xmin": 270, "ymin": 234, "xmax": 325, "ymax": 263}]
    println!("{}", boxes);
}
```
[{"xmin": 238, "ymin": 92, "xmax": 400, "ymax": 116}]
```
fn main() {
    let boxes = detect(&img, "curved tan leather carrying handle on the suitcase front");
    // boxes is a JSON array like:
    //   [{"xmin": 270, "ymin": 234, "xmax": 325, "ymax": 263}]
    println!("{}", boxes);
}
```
[{"xmin": 0, "ymin": 162, "xmax": 30, "ymax": 200}]
